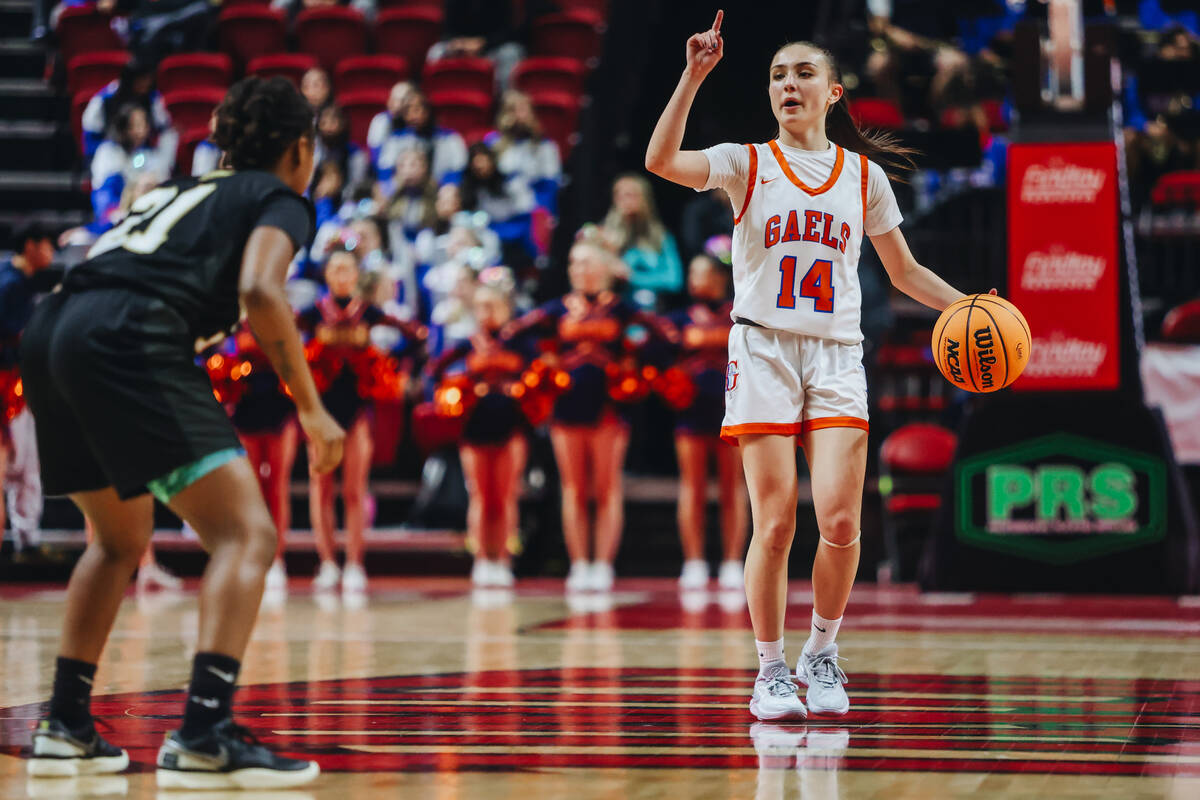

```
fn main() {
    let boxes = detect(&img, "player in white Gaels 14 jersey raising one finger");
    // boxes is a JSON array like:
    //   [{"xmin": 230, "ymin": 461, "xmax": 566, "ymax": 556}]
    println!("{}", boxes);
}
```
[{"xmin": 646, "ymin": 11, "xmax": 964, "ymax": 720}]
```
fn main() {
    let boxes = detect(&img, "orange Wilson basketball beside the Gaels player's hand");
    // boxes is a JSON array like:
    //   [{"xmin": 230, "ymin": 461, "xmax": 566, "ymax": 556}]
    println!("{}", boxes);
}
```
[{"xmin": 934, "ymin": 294, "xmax": 1032, "ymax": 392}]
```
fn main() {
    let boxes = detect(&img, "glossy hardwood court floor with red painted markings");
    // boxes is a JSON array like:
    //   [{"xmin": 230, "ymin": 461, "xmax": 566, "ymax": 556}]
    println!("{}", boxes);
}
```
[{"xmin": 0, "ymin": 579, "xmax": 1200, "ymax": 800}]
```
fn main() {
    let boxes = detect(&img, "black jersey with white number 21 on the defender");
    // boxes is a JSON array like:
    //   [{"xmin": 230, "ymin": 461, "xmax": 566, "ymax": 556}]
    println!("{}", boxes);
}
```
[{"xmin": 64, "ymin": 170, "xmax": 313, "ymax": 339}]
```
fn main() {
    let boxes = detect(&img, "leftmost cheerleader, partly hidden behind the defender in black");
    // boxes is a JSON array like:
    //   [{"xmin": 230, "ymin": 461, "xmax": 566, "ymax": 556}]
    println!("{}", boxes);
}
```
[{"xmin": 218, "ymin": 330, "xmax": 299, "ymax": 593}]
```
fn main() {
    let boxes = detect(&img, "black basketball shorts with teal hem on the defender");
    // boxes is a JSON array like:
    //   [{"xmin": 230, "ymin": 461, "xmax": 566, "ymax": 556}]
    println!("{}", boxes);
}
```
[{"xmin": 22, "ymin": 288, "xmax": 241, "ymax": 499}]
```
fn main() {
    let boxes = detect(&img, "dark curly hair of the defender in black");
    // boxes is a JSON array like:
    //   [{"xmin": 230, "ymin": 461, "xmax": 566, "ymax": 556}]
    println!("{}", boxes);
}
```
[{"xmin": 212, "ymin": 77, "xmax": 313, "ymax": 170}]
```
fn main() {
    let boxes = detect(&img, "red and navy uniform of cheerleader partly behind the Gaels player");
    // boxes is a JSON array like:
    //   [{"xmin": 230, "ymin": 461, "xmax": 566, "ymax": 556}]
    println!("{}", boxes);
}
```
[{"xmin": 667, "ymin": 300, "xmax": 733, "ymax": 437}]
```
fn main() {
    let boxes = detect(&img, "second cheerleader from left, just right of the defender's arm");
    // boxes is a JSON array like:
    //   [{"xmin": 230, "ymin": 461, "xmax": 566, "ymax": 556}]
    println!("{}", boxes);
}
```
[{"xmin": 298, "ymin": 246, "xmax": 426, "ymax": 594}]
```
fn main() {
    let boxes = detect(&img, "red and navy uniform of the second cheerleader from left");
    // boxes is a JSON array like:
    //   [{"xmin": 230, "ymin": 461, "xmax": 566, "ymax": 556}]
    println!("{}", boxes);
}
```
[{"xmin": 296, "ymin": 295, "xmax": 424, "ymax": 428}]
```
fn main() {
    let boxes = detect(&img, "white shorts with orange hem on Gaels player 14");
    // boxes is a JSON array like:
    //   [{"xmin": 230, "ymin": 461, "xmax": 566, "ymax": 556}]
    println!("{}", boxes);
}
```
[{"xmin": 721, "ymin": 324, "xmax": 868, "ymax": 445}]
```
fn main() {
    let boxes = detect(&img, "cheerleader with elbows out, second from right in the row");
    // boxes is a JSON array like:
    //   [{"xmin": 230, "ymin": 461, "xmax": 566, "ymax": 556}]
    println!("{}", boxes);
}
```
[{"xmin": 505, "ymin": 239, "xmax": 674, "ymax": 591}]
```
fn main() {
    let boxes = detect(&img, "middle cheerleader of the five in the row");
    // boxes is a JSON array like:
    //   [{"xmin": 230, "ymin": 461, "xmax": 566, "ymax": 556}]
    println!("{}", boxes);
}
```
[{"xmin": 430, "ymin": 267, "xmax": 536, "ymax": 588}]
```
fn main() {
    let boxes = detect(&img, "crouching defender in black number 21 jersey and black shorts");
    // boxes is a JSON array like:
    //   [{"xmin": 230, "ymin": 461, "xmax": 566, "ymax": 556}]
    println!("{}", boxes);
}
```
[{"xmin": 22, "ymin": 78, "xmax": 344, "ymax": 789}]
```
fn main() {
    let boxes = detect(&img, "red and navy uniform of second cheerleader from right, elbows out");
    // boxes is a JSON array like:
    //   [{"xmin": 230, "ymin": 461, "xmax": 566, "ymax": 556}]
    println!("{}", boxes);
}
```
[{"xmin": 504, "ymin": 291, "xmax": 676, "ymax": 425}]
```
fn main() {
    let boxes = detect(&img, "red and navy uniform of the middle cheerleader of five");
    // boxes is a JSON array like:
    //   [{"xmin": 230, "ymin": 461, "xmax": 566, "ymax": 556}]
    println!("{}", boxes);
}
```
[{"xmin": 430, "ymin": 331, "xmax": 536, "ymax": 445}]
